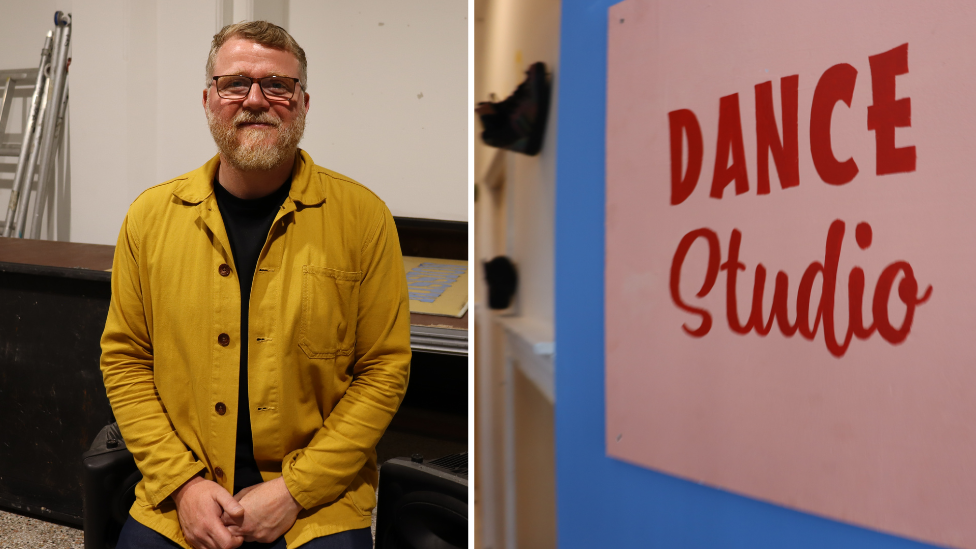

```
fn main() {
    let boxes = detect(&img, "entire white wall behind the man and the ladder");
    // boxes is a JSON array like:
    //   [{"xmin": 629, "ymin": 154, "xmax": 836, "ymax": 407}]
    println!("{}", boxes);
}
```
[{"xmin": 0, "ymin": 0, "xmax": 468, "ymax": 244}]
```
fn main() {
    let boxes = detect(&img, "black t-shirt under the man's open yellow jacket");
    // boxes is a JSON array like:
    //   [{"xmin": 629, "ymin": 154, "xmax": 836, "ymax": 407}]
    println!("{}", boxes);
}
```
[{"xmin": 214, "ymin": 179, "xmax": 291, "ymax": 494}]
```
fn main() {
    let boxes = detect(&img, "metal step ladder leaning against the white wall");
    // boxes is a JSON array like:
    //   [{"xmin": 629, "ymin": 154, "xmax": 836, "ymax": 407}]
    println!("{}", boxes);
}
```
[{"xmin": 0, "ymin": 11, "xmax": 71, "ymax": 240}]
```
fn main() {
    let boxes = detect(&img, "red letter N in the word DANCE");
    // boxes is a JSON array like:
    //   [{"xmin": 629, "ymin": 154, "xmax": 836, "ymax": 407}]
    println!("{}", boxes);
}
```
[{"xmin": 756, "ymin": 74, "xmax": 800, "ymax": 194}]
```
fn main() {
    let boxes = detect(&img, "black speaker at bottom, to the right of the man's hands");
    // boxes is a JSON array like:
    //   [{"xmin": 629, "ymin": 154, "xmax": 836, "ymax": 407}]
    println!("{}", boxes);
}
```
[{"xmin": 376, "ymin": 452, "xmax": 468, "ymax": 549}]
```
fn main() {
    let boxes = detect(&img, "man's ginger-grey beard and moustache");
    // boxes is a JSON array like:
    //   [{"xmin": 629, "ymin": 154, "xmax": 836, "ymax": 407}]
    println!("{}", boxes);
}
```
[{"xmin": 206, "ymin": 104, "xmax": 305, "ymax": 171}]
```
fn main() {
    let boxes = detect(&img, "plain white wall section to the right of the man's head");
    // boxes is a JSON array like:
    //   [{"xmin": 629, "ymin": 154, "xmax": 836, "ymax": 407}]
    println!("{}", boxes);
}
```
[{"xmin": 289, "ymin": 0, "xmax": 468, "ymax": 221}]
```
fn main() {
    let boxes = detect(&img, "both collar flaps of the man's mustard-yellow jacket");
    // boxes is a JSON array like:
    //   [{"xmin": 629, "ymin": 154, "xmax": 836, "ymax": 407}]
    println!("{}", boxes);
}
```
[{"xmin": 173, "ymin": 149, "xmax": 325, "ymax": 206}]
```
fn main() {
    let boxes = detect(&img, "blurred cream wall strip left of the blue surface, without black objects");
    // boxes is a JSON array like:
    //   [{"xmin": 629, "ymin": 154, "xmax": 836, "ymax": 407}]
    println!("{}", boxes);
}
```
[{"xmin": 474, "ymin": 0, "xmax": 560, "ymax": 549}]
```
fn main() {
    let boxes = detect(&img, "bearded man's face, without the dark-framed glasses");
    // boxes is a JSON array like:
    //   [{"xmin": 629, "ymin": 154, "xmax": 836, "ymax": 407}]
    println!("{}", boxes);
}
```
[{"xmin": 203, "ymin": 38, "xmax": 308, "ymax": 171}]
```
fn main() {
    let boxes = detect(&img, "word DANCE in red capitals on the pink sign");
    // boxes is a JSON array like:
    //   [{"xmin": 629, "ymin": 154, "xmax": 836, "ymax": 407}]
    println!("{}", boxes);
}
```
[{"xmin": 668, "ymin": 43, "xmax": 916, "ymax": 201}]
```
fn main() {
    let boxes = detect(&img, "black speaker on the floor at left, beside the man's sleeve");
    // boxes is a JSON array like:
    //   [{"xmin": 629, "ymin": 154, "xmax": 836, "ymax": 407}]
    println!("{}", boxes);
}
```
[{"xmin": 82, "ymin": 423, "xmax": 142, "ymax": 549}]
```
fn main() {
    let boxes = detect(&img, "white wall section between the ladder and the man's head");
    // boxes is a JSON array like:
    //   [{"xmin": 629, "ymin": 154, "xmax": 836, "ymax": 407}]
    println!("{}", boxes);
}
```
[{"xmin": 62, "ymin": 0, "xmax": 216, "ymax": 244}]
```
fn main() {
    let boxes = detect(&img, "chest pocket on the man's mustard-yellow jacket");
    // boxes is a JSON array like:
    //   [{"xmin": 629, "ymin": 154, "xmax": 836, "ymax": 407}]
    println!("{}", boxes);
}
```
[{"xmin": 298, "ymin": 265, "xmax": 363, "ymax": 358}]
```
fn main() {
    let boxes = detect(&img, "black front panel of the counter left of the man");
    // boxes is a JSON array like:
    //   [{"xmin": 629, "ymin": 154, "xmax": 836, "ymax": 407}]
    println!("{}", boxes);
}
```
[{"xmin": 0, "ymin": 268, "xmax": 113, "ymax": 524}]
